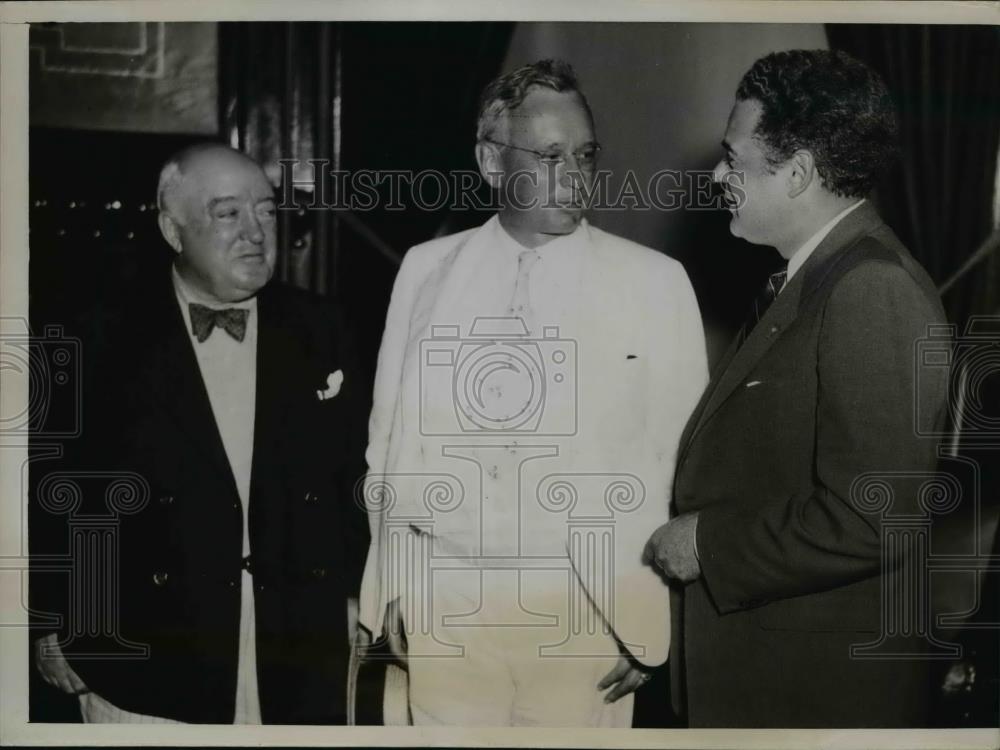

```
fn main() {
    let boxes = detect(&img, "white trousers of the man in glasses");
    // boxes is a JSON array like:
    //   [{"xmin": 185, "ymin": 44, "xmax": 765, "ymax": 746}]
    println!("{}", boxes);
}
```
[{"xmin": 402, "ymin": 569, "xmax": 633, "ymax": 727}]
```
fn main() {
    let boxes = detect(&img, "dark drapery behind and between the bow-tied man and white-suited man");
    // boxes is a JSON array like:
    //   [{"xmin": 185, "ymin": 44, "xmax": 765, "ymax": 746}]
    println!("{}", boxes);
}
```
[{"xmin": 219, "ymin": 22, "xmax": 514, "ymax": 388}]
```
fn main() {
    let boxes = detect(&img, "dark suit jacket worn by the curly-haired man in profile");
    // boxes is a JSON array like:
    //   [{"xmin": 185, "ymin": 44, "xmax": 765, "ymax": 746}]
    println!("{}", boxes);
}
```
[{"xmin": 672, "ymin": 203, "xmax": 947, "ymax": 727}]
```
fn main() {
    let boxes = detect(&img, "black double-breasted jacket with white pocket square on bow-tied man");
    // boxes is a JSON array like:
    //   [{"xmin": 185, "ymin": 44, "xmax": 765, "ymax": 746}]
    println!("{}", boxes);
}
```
[{"xmin": 32, "ymin": 276, "xmax": 367, "ymax": 723}]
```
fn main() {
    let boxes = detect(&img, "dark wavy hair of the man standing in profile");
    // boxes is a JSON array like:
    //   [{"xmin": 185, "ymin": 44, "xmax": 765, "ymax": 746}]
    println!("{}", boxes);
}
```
[{"xmin": 736, "ymin": 50, "xmax": 899, "ymax": 198}]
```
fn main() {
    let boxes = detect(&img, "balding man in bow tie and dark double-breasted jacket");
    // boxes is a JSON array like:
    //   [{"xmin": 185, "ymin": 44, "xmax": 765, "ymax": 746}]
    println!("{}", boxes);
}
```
[{"xmin": 32, "ymin": 144, "xmax": 368, "ymax": 724}]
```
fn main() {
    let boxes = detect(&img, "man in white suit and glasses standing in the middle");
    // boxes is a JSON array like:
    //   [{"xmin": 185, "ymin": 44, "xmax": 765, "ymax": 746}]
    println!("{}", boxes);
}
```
[{"xmin": 360, "ymin": 60, "xmax": 707, "ymax": 727}]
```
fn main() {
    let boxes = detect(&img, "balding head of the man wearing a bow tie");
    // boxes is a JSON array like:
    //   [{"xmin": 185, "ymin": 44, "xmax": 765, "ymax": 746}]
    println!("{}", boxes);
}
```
[{"xmin": 157, "ymin": 143, "xmax": 277, "ymax": 303}]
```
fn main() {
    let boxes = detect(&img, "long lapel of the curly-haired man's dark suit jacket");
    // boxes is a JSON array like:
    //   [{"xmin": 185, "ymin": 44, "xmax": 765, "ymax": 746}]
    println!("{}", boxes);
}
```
[{"xmin": 681, "ymin": 201, "xmax": 882, "ymax": 461}]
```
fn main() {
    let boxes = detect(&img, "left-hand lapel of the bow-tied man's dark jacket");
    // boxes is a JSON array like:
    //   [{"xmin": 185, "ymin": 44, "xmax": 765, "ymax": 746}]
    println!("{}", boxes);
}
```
[{"xmin": 146, "ymin": 275, "xmax": 236, "ymax": 494}]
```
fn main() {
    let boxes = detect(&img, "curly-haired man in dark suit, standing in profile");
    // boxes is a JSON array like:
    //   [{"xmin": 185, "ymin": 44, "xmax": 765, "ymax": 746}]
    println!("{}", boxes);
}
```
[{"xmin": 646, "ymin": 50, "xmax": 947, "ymax": 727}]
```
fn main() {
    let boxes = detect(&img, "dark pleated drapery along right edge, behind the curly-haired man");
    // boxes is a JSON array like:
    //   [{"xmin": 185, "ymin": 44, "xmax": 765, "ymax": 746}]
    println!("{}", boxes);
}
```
[{"xmin": 827, "ymin": 26, "xmax": 1000, "ymax": 726}]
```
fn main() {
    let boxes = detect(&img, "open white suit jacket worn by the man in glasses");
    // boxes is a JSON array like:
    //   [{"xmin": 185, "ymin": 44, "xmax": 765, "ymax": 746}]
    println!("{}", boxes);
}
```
[{"xmin": 360, "ymin": 217, "xmax": 708, "ymax": 665}]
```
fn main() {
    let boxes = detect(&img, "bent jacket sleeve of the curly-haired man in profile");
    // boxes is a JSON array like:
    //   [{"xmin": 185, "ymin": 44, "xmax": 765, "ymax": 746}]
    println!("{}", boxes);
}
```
[{"xmin": 697, "ymin": 261, "xmax": 948, "ymax": 613}]
